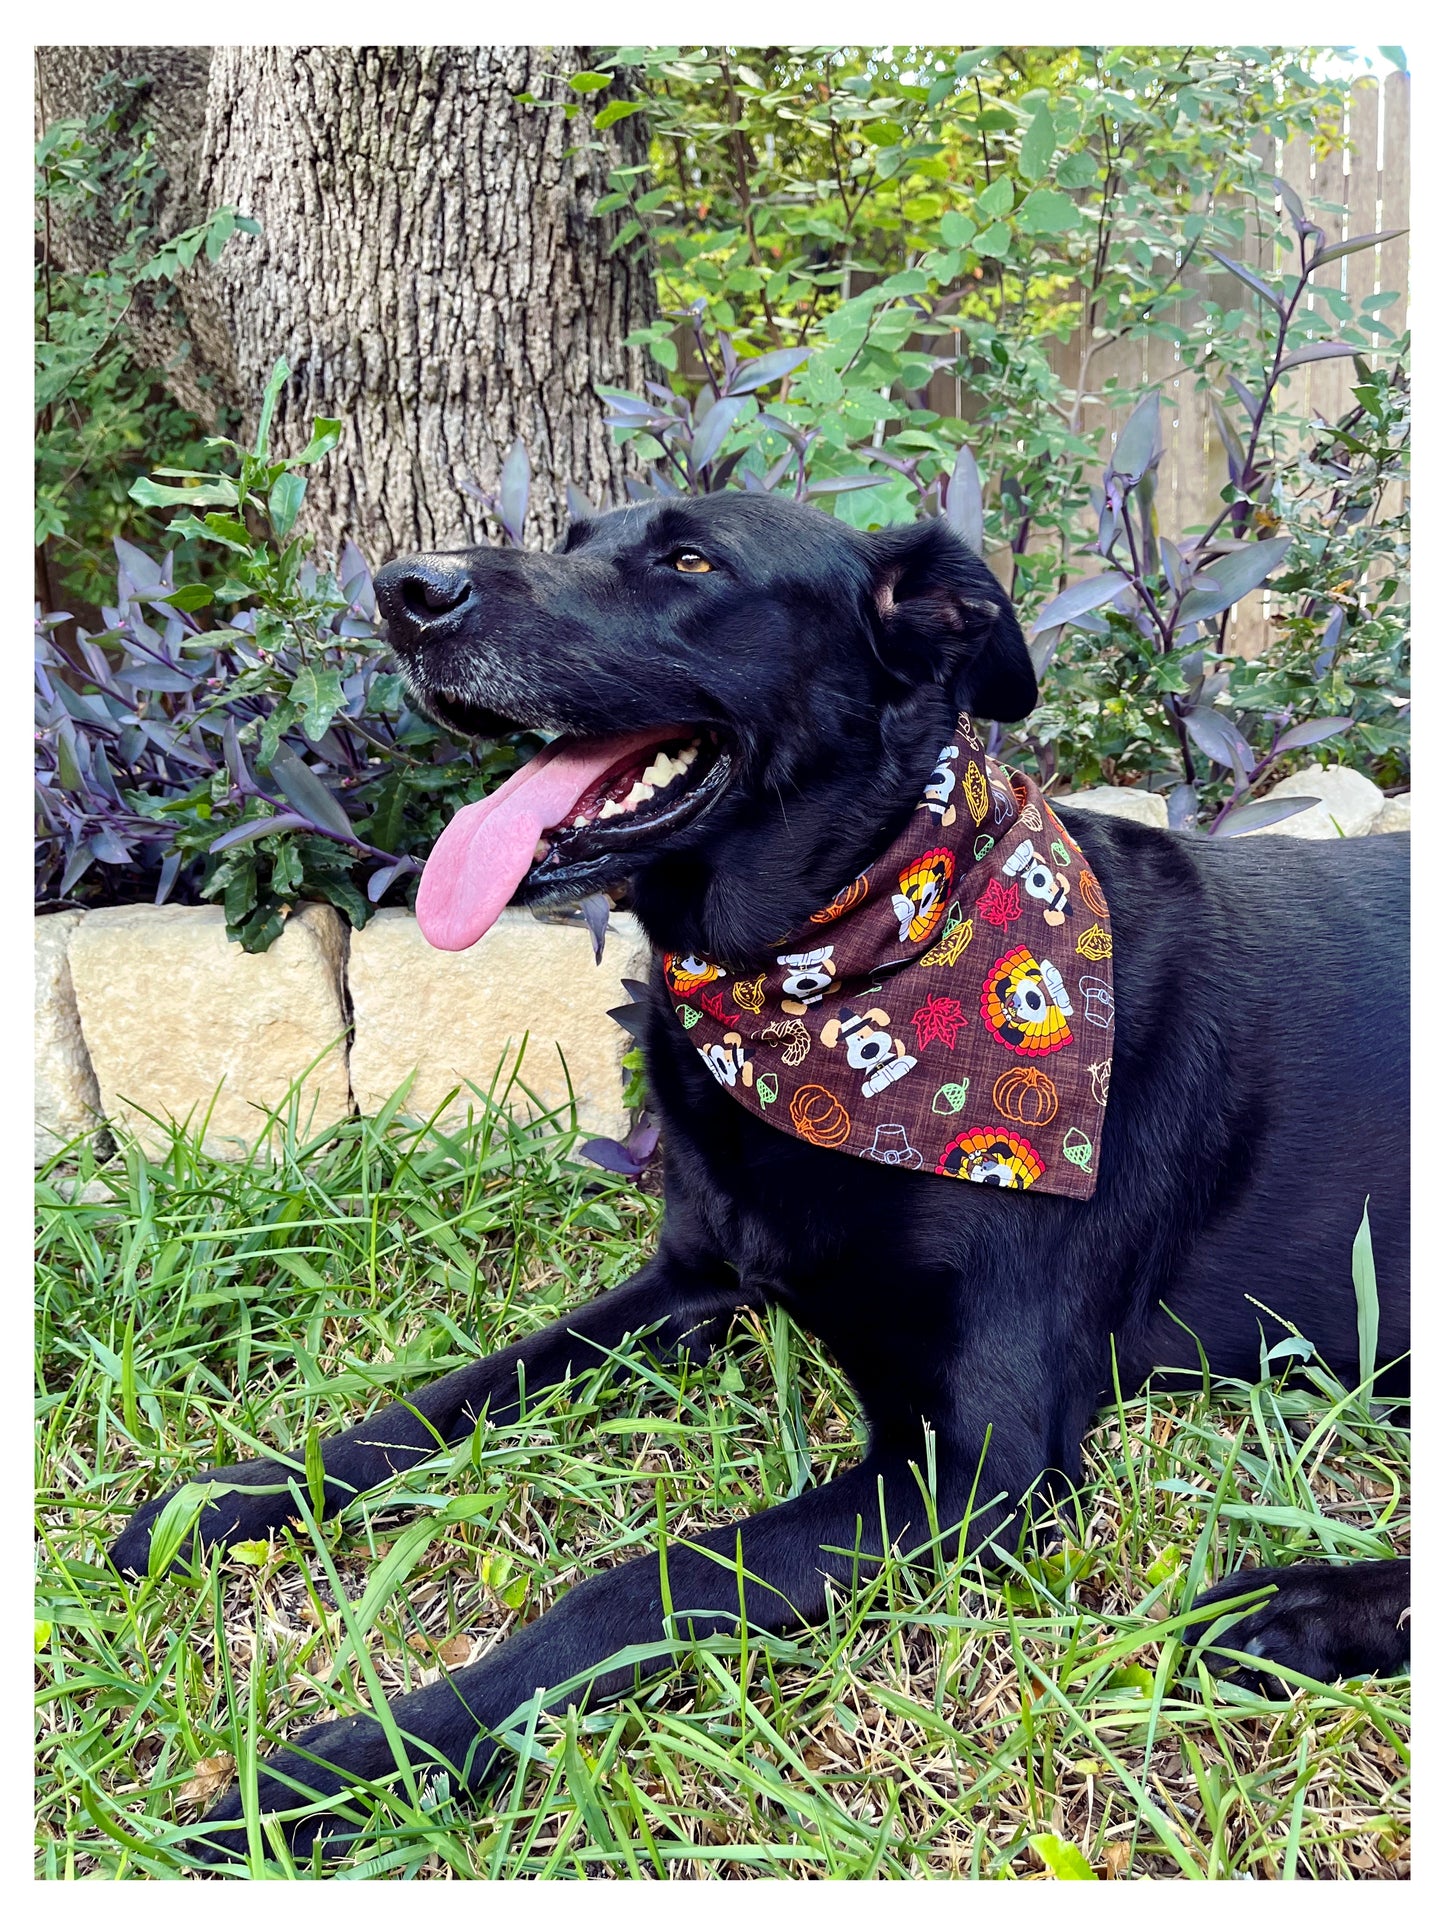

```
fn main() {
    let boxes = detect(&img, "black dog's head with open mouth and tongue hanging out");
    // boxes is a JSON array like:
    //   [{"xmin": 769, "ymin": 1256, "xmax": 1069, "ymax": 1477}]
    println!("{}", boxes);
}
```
[{"xmin": 376, "ymin": 493, "xmax": 1037, "ymax": 957}]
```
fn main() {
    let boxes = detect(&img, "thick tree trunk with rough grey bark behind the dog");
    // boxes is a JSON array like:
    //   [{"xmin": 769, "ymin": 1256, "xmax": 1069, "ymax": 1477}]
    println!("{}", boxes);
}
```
[{"xmin": 40, "ymin": 46, "xmax": 651, "ymax": 564}]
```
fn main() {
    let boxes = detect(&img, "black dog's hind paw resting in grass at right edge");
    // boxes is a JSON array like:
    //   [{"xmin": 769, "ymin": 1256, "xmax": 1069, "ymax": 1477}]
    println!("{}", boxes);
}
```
[{"xmin": 1185, "ymin": 1558, "xmax": 1410, "ymax": 1699}]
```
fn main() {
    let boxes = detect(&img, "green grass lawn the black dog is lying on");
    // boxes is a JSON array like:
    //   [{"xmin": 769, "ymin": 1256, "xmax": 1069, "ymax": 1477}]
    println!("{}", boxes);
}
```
[{"xmin": 37, "ymin": 1109, "xmax": 1408, "ymax": 1880}]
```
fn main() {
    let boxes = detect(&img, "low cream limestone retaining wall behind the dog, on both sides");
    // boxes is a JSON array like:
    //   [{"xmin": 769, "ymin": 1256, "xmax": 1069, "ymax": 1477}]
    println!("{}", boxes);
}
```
[{"xmin": 35, "ymin": 767, "xmax": 1410, "ymax": 1163}]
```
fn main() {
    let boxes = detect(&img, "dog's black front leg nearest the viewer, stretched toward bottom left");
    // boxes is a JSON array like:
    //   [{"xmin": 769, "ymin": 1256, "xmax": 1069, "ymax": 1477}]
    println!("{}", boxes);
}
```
[{"xmin": 181, "ymin": 1456, "xmax": 948, "ymax": 1861}]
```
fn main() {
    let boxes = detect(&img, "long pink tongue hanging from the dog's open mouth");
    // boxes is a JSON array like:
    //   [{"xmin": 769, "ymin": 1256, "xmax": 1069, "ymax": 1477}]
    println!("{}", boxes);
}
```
[{"xmin": 416, "ymin": 728, "xmax": 678, "ymax": 950}]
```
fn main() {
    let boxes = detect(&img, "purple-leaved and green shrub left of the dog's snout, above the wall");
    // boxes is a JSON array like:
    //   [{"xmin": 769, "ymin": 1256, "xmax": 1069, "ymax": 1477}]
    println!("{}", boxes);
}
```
[{"xmin": 37, "ymin": 362, "xmax": 524, "ymax": 950}]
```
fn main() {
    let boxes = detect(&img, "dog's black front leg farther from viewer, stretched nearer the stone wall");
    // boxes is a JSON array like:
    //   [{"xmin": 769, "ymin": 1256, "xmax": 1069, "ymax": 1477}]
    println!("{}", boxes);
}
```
[{"xmin": 110, "ymin": 1250, "xmax": 749, "ymax": 1577}]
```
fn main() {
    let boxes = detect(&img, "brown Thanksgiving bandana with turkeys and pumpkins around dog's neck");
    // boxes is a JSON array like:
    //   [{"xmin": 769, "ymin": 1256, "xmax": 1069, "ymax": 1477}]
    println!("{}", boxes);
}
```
[{"xmin": 663, "ymin": 716, "xmax": 1114, "ymax": 1198}]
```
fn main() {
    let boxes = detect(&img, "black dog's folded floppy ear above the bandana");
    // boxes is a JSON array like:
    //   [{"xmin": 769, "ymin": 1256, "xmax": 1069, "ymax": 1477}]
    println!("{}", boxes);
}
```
[{"xmin": 869, "ymin": 518, "xmax": 1038, "ymax": 722}]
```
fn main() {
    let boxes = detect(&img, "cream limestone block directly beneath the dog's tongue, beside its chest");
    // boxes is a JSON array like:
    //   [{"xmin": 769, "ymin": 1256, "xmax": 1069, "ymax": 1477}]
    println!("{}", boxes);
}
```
[{"xmin": 347, "ymin": 909, "xmax": 649, "ymax": 1136}]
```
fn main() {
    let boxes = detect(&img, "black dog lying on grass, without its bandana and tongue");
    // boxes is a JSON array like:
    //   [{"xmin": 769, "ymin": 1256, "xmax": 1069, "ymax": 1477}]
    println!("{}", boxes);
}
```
[{"xmin": 114, "ymin": 493, "xmax": 1408, "ymax": 1849}]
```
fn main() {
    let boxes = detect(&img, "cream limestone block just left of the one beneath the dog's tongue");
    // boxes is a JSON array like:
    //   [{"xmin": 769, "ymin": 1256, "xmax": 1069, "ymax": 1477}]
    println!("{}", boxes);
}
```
[{"xmin": 71, "ymin": 903, "xmax": 351, "ymax": 1158}]
